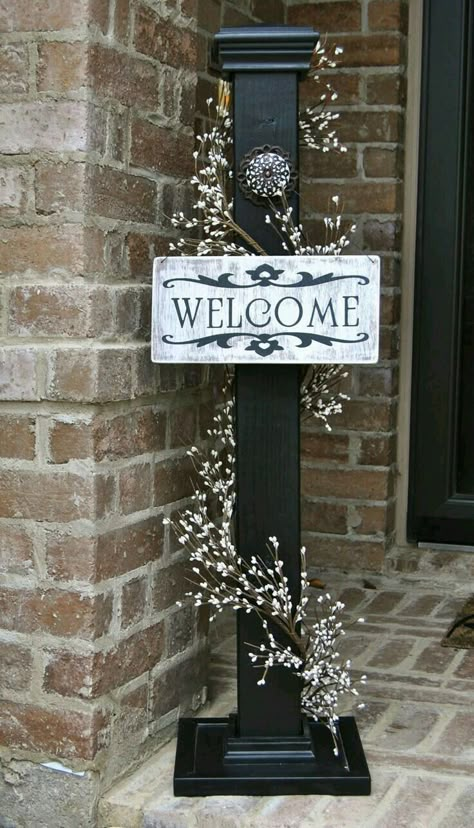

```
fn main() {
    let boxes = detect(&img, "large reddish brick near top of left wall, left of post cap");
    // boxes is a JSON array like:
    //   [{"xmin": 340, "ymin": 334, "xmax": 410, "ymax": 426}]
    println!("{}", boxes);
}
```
[{"xmin": 134, "ymin": 6, "xmax": 197, "ymax": 69}]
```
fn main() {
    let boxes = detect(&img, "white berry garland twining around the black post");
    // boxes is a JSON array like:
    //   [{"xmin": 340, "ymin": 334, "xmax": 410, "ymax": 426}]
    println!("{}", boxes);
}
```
[{"xmin": 165, "ymin": 45, "xmax": 365, "ymax": 755}]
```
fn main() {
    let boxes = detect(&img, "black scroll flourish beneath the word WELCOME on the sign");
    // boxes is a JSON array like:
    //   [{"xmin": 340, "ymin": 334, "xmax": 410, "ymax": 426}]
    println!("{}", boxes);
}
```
[{"xmin": 162, "ymin": 331, "xmax": 369, "ymax": 357}]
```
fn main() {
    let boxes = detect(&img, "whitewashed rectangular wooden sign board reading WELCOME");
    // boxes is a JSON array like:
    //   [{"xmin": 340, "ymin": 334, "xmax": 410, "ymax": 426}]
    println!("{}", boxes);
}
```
[{"xmin": 152, "ymin": 256, "xmax": 380, "ymax": 363}]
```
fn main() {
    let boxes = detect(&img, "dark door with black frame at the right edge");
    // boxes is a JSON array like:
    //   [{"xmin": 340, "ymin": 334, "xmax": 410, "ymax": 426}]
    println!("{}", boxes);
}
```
[{"xmin": 408, "ymin": 0, "xmax": 474, "ymax": 545}]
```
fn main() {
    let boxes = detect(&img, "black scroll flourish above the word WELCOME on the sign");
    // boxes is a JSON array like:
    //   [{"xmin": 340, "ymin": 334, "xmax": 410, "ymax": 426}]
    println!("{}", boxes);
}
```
[{"xmin": 163, "ymin": 264, "xmax": 370, "ymax": 289}]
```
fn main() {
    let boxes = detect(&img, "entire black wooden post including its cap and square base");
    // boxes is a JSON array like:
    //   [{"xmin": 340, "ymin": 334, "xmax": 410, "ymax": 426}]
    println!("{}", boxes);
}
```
[{"xmin": 174, "ymin": 26, "xmax": 370, "ymax": 796}]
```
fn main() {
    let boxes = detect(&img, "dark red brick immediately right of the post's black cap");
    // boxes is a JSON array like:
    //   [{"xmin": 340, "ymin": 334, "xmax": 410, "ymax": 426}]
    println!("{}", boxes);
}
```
[{"xmin": 328, "ymin": 33, "xmax": 404, "ymax": 68}]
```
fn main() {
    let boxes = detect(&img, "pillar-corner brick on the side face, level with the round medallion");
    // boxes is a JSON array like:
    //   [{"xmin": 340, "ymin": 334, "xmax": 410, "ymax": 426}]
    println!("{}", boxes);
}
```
[{"xmin": 87, "ymin": 167, "xmax": 156, "ymax": 224}]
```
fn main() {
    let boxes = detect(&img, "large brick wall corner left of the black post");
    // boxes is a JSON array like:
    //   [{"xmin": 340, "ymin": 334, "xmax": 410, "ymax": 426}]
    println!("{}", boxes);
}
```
[{"xmin": 0, "ymin": 0, "xmax": 284, "ymax": 828}]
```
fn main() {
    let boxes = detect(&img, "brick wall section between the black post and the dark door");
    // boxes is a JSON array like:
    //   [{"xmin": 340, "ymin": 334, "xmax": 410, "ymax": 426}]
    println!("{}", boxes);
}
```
[{"xmin": 288, "ymin": 0, "xmax": 407, "ymax": 571}]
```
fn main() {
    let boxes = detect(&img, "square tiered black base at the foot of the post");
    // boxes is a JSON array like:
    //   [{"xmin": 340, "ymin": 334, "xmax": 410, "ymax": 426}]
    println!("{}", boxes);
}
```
[{"xmin": 174, "ymin": 716, "xmax": 370, "ymax": 796}]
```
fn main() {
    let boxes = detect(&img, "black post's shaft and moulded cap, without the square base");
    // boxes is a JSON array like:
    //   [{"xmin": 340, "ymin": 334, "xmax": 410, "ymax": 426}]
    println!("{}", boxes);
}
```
[{"xmin": 226, "ymin": 27, "xmax": 318, "ymax": 736}]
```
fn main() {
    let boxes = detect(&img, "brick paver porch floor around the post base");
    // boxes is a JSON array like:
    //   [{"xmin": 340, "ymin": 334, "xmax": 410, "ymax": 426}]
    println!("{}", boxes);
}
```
[{"xmin": 101, "ymin": 575, "xmax": 474, "ymax": 828}]
